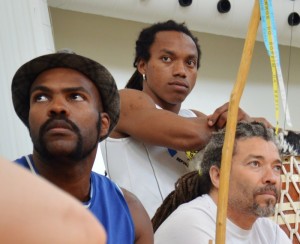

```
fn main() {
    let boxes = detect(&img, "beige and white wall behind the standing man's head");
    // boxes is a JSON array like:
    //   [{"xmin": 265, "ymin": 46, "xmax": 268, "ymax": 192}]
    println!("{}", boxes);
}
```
[{"xmin": 50, "ymin": 8, "xmax": 300, "ymax": 130}]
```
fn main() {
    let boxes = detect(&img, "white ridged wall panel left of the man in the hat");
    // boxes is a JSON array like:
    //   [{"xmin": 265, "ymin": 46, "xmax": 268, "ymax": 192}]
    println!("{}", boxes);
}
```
[{"xmin": 0, "ymin": 0, "xmax": 54, "ymax": 160}]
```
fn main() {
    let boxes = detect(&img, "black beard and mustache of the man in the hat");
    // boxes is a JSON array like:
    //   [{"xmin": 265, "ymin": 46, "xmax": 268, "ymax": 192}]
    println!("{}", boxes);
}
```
[{"xmin": 30, "ymin": 113, "xmax": 101, "ymax": 162}]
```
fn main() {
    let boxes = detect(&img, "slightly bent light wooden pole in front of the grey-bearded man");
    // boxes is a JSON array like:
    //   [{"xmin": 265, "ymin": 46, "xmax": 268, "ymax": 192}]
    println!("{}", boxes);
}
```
[{"xmin": 216, "ymin": 0, "xmax": 260, "ymax": 244}]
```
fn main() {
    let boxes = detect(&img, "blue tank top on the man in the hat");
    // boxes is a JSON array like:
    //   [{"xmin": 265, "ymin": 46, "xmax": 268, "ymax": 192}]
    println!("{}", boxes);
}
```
[{"xmin": 15, "ymin": 155, "xmax": 135, "ymax": 244}]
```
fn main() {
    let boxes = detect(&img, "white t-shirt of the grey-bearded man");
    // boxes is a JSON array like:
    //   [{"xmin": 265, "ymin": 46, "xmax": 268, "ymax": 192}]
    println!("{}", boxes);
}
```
[{"xmin": 154, "ymin": 195, "xmax": 292, "ymax": 244}]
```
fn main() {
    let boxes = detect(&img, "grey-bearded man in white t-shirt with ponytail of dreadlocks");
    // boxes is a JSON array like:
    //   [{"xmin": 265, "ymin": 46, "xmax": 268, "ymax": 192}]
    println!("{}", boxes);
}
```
[{"xmin": 152, "ymin": 122, "xmax": 291, "ymax": 244}]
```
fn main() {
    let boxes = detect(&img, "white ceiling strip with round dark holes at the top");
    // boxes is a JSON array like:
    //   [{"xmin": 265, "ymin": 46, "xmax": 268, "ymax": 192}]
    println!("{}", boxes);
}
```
[{"xmin": 47, "ymin": 0, "xmax": 300, "ymax": 47}]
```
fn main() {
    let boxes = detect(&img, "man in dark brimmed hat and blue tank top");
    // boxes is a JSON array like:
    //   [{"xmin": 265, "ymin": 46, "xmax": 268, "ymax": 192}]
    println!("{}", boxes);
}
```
[{"xmin": 12, "ymin": 52, "xmax": 153, "ymax": 244}]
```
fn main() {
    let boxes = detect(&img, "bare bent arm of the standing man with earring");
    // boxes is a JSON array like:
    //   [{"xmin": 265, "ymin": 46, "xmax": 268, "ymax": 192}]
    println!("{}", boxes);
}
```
[{"xmin": 110, "ymin": 89, "xmax": 214, "ymax": 151}]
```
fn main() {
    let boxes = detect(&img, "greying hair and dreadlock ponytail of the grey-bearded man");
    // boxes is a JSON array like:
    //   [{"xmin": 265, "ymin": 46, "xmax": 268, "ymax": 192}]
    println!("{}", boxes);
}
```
[{"xmin": 151, "ymin": 122, "xmax": 278, "ymax": 232}]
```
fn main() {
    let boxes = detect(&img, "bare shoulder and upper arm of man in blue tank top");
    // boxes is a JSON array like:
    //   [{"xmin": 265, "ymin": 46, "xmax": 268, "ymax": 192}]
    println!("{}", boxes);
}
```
[{"xmin": 122, "ymin": 188, "xmax": 154, "ymax": 244}]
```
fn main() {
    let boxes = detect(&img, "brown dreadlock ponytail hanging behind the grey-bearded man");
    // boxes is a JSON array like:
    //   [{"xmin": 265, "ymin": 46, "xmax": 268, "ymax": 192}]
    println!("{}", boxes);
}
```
[{"xmin": 151, "ymin": 171, "xmax": 209, "ymax": 232}]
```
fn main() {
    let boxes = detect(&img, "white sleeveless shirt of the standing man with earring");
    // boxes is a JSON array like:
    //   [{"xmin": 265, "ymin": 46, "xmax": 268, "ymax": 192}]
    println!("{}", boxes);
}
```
[{"xmin": 100, "ymin": 109, "xmax": 196, "ymax": 218}]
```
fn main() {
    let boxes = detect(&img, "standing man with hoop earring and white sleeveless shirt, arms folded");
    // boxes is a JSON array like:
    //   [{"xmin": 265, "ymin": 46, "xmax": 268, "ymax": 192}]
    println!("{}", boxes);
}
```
[{"xmin": 101, "ymin": 20, "xmax": 270, "ymax": 217}]
